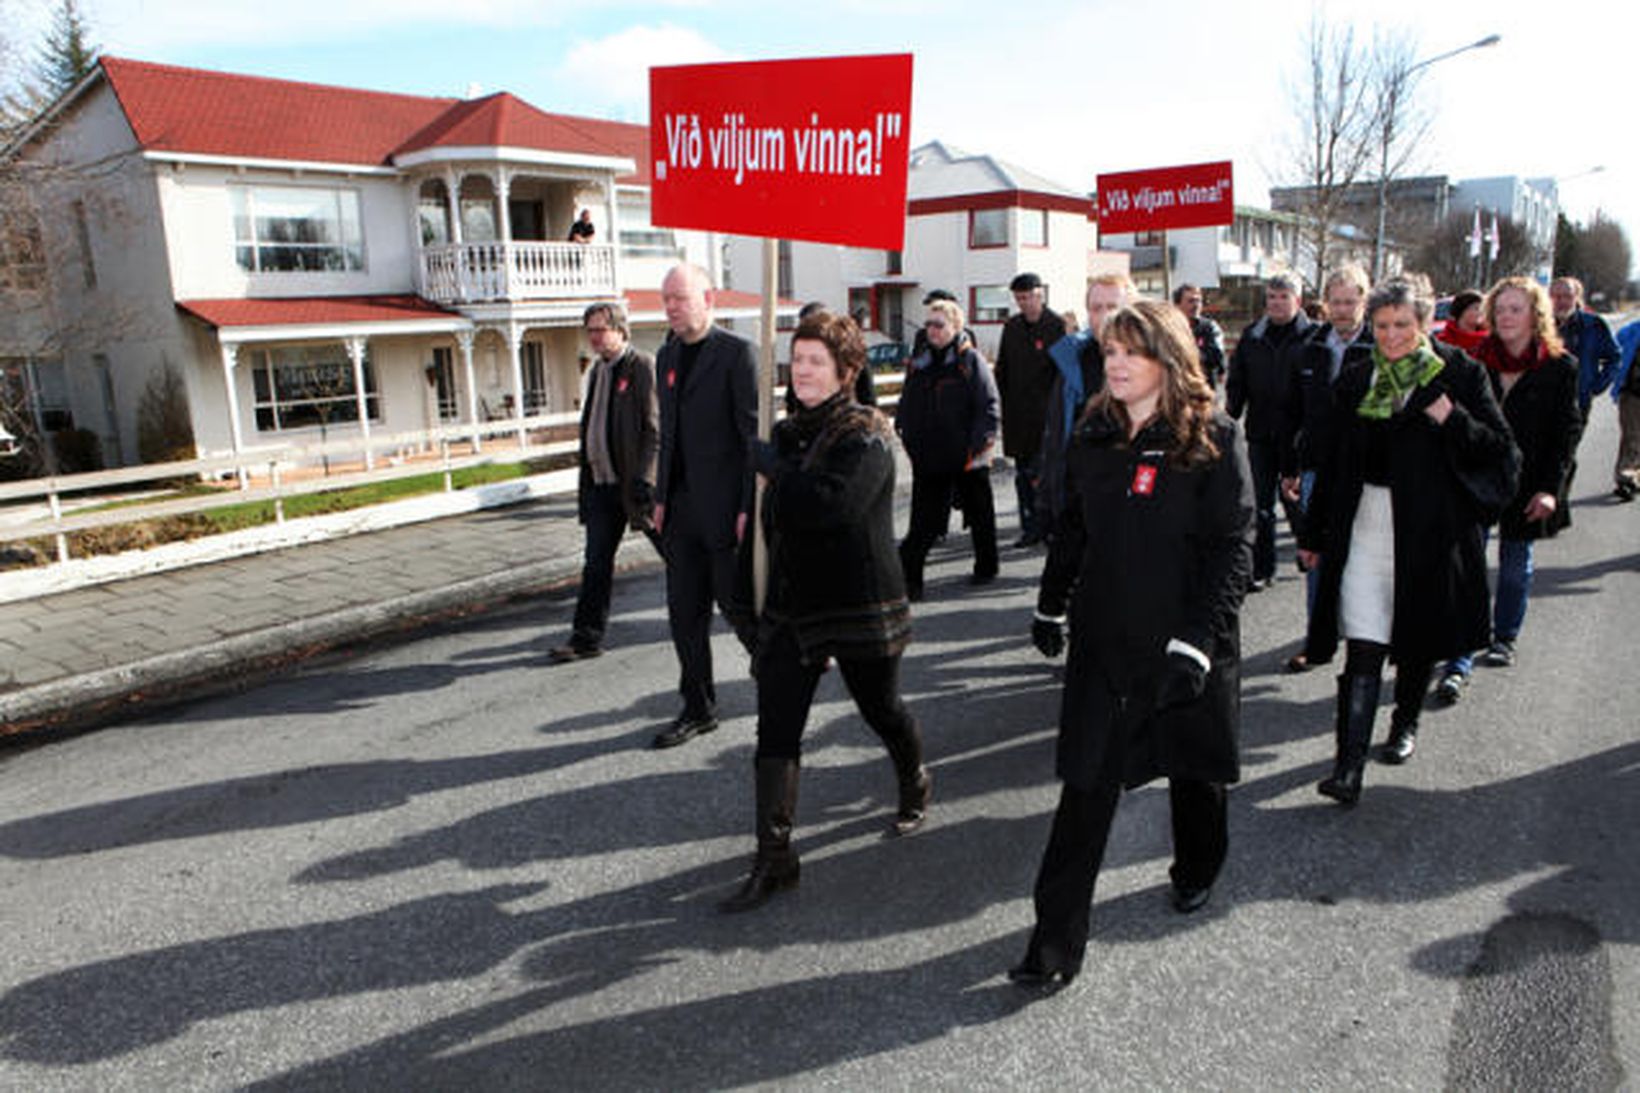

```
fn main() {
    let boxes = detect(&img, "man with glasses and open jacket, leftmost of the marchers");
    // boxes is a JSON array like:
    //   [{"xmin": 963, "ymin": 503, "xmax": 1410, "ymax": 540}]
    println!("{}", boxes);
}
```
[{"xmin": 548, "ymin": 304, "xmax": 661, "ymax": 665}]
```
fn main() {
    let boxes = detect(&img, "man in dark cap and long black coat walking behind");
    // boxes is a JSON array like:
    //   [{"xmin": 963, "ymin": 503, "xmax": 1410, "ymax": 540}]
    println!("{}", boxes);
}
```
[{"xmin": 992, "ymin": 272, "xmax": 1064, "ymax": 547}]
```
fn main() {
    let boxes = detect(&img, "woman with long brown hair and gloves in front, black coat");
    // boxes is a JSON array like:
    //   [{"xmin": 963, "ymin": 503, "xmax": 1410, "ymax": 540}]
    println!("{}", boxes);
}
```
[{"xmin": 1009, "ymin": 300, "xmax": 1253, "ymax": 986}]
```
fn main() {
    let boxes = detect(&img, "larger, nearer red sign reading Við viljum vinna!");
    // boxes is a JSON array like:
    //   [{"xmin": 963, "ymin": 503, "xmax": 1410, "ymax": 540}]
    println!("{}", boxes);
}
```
[{"xmin": 649, "ymin": 54, "xmax": 912, "ymax": 251}]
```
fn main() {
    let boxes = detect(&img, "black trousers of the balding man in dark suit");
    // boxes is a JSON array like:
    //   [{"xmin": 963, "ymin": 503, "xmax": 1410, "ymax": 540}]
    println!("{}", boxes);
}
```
[{"xmin": 661, "ymin": 492, "xmax": 747, "ymax": 719}]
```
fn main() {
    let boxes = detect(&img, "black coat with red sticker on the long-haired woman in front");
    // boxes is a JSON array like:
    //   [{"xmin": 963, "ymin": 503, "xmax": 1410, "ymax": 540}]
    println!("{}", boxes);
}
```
[{"xmin": 1036, "ymin": 414, "xmax": 1253, "ymax": 789}]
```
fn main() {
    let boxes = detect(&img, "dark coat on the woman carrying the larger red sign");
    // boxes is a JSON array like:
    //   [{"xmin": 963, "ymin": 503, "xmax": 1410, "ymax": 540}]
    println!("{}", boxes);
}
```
[{"xmin": 753, "ymin": 392, "xmax": 912, "ymax": 661}]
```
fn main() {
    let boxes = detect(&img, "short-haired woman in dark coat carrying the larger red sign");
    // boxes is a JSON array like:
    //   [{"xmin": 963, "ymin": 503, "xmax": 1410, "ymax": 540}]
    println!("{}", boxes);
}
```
[{"xmin": 718, "ymin": 312, "xmax": 933, "ymax": 911}]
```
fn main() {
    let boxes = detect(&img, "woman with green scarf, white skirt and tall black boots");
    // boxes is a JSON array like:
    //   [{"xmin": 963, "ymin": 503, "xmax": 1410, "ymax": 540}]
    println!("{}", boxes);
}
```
[{"xmin": 1299, "ymin": 281, "xmax": 1520, "ymax": 804}]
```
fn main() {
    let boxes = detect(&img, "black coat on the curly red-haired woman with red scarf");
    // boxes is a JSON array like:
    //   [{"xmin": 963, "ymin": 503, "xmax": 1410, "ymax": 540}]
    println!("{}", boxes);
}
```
[{"xmin": 1487, "ymin": 353, "xmax": 1583, "ymax": 540}]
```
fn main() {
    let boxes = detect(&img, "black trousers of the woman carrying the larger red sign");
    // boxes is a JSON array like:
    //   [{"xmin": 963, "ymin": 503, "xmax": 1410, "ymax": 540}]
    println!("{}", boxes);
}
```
[{"xmin": 756, "ymin": 625, "xmax": 913, "ymax": 760}]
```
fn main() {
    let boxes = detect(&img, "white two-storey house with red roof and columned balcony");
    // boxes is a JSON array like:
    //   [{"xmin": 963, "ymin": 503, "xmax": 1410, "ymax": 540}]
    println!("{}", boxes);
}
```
[{"xmin": 0, "ymin": 57, "xmax": 774, "ymax": 464}]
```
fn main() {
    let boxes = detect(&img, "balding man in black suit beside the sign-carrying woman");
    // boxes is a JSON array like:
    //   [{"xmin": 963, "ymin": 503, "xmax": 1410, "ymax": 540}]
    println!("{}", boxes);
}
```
[{"xmin": 654, "ymin": 266, "xmax": 758, "ymax": 748}]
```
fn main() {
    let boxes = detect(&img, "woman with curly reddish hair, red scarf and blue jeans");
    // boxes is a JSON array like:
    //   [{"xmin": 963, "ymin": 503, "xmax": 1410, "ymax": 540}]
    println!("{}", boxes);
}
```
[{"xmin": 1438, "ymin": 277, "xmax": 1583, "ymax": 702}]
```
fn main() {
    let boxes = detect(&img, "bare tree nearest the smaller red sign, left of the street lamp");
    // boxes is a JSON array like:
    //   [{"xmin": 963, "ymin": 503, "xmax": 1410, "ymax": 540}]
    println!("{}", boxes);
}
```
[{"xmin": 1286, "ymin": 5, "xmax": 1376, "ymax": 286}]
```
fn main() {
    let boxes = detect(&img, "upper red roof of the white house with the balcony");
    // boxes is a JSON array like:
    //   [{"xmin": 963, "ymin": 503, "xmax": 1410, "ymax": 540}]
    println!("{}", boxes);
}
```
[{"xmin": 98, "ymin": 57, "xmax": 649, "ymax": 184}]
